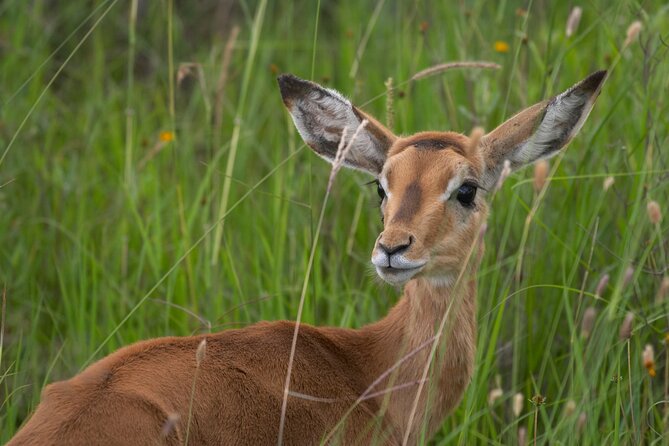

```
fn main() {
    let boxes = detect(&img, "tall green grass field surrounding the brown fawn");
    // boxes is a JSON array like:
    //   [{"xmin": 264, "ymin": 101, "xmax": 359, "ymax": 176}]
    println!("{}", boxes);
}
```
[{"xmin": 0, "ymin": 0, "xmax": 669, "ymax": 445}]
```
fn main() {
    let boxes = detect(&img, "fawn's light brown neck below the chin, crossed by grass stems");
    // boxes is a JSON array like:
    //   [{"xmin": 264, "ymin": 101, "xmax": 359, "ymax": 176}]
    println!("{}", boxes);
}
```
[{"xmin": 358, "ymin": 276, "xmax": 476, "ymax": 437}]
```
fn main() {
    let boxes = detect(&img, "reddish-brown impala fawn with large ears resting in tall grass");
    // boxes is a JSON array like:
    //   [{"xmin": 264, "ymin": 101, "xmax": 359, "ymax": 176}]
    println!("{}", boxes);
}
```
[{"xmin": 10, "ymin": 71, "xmax": 606, "ymax": 445}]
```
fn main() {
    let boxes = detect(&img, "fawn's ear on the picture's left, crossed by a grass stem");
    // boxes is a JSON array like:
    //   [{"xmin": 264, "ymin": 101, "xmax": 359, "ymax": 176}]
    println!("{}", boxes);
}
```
[{"xmin": 278, "ymin": 74, "xmax": 397, "ymax": 175}]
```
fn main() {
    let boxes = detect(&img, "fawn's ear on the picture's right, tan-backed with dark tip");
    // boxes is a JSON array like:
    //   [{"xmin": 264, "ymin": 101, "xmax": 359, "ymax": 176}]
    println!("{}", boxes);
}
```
[{"xmin": 480, "ymin": 71, "xmax": 606, "ymax": 187}]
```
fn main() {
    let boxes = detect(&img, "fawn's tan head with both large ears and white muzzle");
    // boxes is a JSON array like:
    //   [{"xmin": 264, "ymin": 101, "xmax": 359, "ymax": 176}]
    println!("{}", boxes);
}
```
[{"xmin": 278, "ymin": 71, "xmax": 606, "ymax": 285}]
